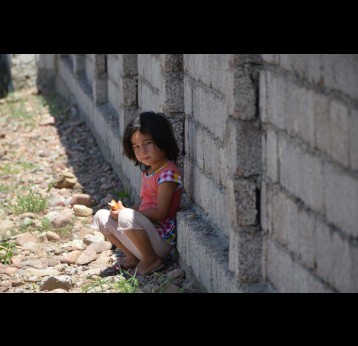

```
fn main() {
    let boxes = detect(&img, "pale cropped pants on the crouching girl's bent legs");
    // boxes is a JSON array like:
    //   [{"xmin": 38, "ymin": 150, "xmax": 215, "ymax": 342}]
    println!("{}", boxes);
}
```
[{"xmin": 93, "ymin": 208, "xmax": 172, "ymax": 260}]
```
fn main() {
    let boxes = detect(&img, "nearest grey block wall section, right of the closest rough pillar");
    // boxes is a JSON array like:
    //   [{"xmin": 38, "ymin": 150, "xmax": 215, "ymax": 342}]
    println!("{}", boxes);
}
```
[{"xmin": 259, "ymin": 54, "xmax": 358, "ymax": 292}]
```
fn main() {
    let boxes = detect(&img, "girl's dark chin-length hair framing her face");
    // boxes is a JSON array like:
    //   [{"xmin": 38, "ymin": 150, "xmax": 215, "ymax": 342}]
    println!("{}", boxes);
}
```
[{"xmin": 122, "ymin": 112, "xmax": 179, "ymax": 171}]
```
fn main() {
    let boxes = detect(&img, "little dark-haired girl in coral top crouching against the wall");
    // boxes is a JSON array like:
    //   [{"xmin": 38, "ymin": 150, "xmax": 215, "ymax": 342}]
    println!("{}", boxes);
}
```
[{"xmin": 94, "ymin": 112, "xmax": 182, "ymax": 275}]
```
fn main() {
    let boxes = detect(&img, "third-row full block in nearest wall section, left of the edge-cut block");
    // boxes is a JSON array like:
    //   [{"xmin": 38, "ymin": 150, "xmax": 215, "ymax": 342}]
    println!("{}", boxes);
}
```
[{"xmin": 278, "ymin": 135, "xmax": 324, "ymax": 212}]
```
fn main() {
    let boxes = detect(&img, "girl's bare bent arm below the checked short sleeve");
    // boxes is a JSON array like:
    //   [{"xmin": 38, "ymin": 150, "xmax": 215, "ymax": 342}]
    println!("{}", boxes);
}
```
[{"xmin": 140, "ymin": 181, "xmax": 178, "ymax": 222}]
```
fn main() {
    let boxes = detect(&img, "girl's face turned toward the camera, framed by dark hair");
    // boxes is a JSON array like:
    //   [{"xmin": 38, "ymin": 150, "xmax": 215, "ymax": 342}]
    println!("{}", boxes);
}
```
[{"xmin": 131, "ymin": 131, "xmax": 167, "ymax": 170}]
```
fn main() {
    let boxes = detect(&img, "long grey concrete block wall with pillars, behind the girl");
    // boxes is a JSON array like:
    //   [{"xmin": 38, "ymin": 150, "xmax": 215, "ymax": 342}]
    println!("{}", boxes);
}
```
[{"xmin": 40, "ymin": 54, "xmax": 358, "ymax": 292}]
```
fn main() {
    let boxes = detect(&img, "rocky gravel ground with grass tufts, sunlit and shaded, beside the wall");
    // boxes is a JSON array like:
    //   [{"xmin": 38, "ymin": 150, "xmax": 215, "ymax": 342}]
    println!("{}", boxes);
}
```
[{"xmin": 0, "ymin": 89, "xmax": 197, "ymax": 293}]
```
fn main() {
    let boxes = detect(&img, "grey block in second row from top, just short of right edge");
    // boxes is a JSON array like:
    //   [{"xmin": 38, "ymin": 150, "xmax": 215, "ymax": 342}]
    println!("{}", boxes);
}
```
[{"xmin": 315, "ymin": 95, "xmax": 349, "ymax": 167}]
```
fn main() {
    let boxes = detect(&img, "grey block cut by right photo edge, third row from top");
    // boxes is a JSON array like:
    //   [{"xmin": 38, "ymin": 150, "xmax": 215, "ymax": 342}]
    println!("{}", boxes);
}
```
[{"xmin": 324, "ymin": 163, "xmax": 358, "ymax": 237}]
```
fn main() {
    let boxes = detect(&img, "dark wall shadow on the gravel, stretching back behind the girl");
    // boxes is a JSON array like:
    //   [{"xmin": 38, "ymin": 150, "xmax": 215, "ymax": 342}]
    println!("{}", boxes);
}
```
[{"xmin": 40, "ymin": 91, "xmax": 130, "ymax": 211}]
